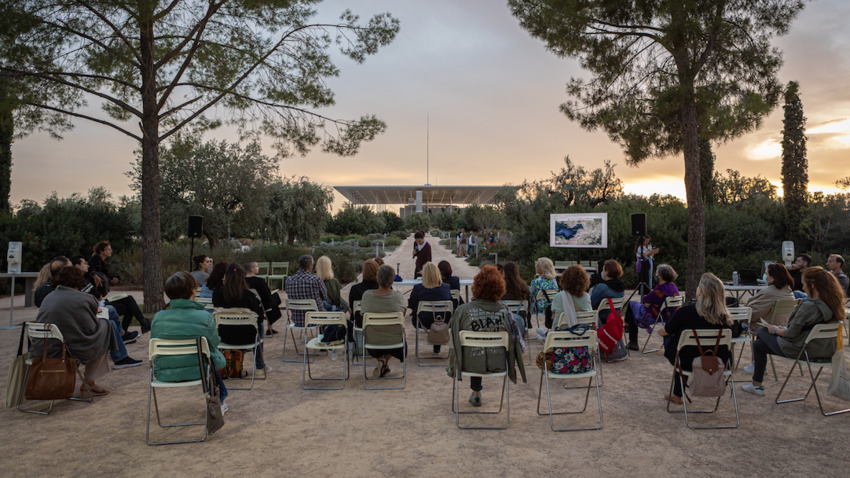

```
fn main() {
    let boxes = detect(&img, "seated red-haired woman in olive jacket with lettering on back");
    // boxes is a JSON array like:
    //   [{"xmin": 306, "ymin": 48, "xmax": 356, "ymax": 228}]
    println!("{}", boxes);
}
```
[{"xmin": 449, "ymin": 266, "xmax": 526, "ymax": 407}]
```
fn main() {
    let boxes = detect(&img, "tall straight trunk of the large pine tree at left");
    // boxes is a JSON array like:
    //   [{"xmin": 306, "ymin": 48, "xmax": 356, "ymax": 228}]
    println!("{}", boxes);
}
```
[{"xmin": 139, "ymin": 6, "xmax": 165, "ymax": 313}]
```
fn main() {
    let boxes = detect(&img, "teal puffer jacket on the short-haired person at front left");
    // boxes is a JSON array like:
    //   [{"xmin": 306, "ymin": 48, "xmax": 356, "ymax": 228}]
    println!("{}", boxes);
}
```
[{"xmin": 151, "ymin": 299, "xmax": 225, "ymax": 382}]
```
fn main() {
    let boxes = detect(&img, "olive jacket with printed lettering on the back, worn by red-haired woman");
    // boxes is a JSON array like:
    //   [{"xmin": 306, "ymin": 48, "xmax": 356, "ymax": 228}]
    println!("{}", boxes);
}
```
[{"xmin": 446, "ymin": 300, "xmax": 526, "ymax": 383}]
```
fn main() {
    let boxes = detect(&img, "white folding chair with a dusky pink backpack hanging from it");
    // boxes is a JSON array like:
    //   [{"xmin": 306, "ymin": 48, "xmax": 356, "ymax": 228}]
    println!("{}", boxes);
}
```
[{"xmin": 667, "ymin": 329, "xmax": 741, "ymax": 430}]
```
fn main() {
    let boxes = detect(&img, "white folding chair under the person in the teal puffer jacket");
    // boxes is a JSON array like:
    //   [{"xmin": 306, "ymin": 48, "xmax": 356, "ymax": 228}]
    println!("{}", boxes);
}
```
[{"xmin": 145, "ymin": 337, "xmax": 213, "ymax": 445}]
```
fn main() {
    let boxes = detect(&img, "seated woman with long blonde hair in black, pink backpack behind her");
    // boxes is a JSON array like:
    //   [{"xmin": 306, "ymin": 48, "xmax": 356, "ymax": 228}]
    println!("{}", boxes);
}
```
[{"xmin": 658, "ymin": 272, "xmax": 732, "ymax": 405}]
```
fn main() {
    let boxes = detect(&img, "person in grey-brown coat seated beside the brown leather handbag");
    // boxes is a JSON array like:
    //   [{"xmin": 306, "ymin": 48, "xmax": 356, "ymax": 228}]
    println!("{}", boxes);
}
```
[{"xmin": 35, "ymin": 266, "xmax": 118, "ymax": 395}]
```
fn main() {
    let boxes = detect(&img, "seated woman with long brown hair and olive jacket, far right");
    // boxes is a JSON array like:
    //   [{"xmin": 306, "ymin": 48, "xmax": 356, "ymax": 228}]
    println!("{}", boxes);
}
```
[{"xmin": 741, "ymin": 266, "xmax": 846, "ymax": 397}]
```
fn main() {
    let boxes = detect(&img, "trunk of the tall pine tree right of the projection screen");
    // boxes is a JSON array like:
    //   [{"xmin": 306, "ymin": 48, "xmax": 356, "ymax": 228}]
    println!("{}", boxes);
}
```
[{"xmin": 680, "ymin": 94, "xmax": 705, "ymax": 300}]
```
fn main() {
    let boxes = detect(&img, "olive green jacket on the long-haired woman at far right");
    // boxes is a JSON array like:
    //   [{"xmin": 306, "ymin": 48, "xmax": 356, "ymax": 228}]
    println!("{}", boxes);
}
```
[{"xmin": 776, "ymin": 299, "xmax": 836, "ymax": 359}]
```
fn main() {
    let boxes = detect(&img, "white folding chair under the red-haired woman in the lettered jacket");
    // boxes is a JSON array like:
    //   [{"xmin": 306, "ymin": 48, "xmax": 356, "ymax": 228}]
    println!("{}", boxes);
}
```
[{"xmin": 452, "ymin": 330, "xmax": 511, "ymax": 430}]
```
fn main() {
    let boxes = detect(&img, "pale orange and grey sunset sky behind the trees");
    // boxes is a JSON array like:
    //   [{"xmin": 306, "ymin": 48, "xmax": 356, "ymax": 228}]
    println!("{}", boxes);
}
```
[{"xmin": 12, "ymin": 0, "xmax": 850, "ymax": 207}]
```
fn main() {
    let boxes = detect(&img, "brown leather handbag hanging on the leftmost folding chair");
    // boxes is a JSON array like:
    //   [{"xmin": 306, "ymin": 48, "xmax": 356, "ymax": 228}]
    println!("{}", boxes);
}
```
[{"xmin": 24, "ymin": 340, "xmax": 77, "ymax": 400}]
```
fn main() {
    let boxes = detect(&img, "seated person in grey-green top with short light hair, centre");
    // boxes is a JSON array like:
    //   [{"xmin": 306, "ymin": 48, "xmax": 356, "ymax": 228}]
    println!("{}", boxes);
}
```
[{"xmin": 360, "ymin": 261, "xmax": 407, "ymax": 378}]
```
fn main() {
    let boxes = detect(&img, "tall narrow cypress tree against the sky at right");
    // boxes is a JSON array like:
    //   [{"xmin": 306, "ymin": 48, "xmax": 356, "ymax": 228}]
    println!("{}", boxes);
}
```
[{"xmin": 782, "ymin": 81, "xmax": 809, "ymax": 238}]
